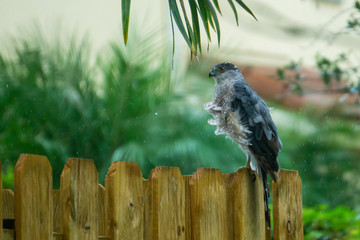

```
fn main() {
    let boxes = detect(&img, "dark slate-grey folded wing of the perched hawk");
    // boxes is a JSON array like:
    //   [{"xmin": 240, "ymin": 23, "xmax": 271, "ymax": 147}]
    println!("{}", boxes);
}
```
[{"xmin": 231, "ymin": 81, "xmax": 282, "ymax": 181}]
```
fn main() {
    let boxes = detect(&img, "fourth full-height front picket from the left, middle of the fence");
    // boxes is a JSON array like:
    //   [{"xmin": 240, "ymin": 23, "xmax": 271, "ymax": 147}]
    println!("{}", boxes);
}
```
[{"xmin": 145, "ymin": 167, "xmax": 186, "ymax": 240}]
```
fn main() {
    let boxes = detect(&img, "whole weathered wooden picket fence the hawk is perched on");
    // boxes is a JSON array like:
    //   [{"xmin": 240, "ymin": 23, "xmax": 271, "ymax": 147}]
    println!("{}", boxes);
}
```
[{"xmin": 0, "ymin": 154, "xmax": 303, "ymax": 240}]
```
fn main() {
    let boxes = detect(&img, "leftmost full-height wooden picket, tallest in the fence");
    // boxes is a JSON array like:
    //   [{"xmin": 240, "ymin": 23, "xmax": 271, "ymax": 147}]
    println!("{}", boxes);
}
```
[{"xmin": 14, "ymin": 154, "xmax": 53, "ymax": 240}]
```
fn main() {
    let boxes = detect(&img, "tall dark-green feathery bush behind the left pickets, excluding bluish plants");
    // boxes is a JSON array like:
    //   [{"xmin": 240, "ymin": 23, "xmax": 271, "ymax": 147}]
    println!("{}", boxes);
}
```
[{"xmin": 0, "ymin": 30, "xmax": 171, "ymax": 187}]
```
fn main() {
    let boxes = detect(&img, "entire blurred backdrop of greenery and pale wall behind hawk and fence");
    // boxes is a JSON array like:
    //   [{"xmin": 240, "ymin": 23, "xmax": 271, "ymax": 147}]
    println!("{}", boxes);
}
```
[{"xmin": 0, "ymin": 0, "xmax": 360, "ymax": 239}]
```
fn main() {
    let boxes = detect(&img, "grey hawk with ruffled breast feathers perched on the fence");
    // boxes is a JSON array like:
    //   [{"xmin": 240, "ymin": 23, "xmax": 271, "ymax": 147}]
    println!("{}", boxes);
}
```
[{"xmin": 204, "ymin": 63, "xmax": 282, "ymax": 227}]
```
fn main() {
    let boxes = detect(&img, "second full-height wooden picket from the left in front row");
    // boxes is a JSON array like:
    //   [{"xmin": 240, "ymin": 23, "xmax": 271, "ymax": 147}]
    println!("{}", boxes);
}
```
[{"xmin": 60, "ymin": 158, "xmax": 99, "ymax": 240}]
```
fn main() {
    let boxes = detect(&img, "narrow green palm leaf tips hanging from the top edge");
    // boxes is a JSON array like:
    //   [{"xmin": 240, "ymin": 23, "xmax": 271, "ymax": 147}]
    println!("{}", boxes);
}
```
[{"xmin": 121, "ymin": 0, "xmax": 257, "ymax": 56}]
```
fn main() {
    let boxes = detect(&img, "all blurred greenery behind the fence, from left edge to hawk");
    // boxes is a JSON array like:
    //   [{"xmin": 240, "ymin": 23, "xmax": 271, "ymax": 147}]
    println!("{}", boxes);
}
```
[{"xmin": 0, "ymin": 29, "xmax": 243, "ymax": 188}]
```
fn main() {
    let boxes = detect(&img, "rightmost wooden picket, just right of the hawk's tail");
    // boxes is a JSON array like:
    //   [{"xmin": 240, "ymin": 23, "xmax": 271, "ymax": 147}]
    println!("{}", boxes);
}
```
[{"xmin": 272, "ymin": 170, "xmax": 304, "ymax": 240}]
